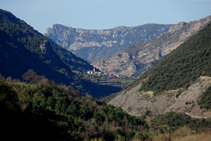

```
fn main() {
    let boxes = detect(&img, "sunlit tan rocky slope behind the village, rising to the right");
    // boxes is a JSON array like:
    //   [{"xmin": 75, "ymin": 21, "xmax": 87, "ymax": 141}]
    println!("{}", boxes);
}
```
[{"xmin": 92, "ymin": 16, "xmax": 211, "ymax": 76}]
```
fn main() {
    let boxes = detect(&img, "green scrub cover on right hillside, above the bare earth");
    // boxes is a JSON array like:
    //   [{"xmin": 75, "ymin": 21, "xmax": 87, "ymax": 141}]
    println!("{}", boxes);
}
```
[{"xmin": 131, "ymin": 24, "xmax": 211, "ymax": 93}]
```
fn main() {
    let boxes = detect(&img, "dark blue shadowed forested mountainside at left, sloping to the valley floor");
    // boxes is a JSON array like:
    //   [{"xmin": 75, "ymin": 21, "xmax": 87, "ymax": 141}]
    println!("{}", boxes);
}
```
[{"xmin": 0, "ymin": 10, "xmax": 121, "ymax": 98}]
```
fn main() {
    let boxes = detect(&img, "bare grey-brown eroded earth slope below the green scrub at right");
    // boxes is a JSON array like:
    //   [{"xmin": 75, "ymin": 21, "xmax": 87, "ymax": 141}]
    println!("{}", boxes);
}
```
[{"xmin": 109, "ymin": 76, "xmax": 211, "ymax": 118}]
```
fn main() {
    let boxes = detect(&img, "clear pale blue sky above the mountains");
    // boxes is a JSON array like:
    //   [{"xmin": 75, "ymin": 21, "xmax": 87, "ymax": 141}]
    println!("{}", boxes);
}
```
[{"xmin": 0, "ymin": 0, "xmax": 211, "ymax": 33}]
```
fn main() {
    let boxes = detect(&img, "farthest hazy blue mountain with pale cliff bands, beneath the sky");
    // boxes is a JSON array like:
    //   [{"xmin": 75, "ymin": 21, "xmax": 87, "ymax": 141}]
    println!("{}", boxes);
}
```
[{"xmin": 44, "ymin": 24, "xmax": 173, "ymax": 61}]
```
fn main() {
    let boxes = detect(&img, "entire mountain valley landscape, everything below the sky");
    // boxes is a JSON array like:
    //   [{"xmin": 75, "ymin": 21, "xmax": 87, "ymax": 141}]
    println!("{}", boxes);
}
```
[{"xmin": 0, "ymin": 9, "xmax": 211, "ymax": 141}]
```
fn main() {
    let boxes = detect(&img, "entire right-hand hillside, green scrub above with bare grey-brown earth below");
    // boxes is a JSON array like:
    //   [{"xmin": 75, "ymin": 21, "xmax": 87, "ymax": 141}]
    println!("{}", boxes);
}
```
[{"xmin": 109, "ymin": 24, "xmax": 211, "ymax": 118}]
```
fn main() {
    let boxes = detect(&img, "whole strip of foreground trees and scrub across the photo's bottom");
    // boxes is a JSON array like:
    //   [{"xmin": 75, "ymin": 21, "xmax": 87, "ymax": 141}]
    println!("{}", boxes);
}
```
[{"xmin": 0, "ymin": 70, "xmax": 211, "ymax": 141}]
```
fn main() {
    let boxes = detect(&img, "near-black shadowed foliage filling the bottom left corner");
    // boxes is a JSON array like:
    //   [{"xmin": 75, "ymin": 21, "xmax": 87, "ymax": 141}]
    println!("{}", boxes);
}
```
[{"xmin": 0, "ymin": 81, "xmax": 81, "ymax": 140}]
